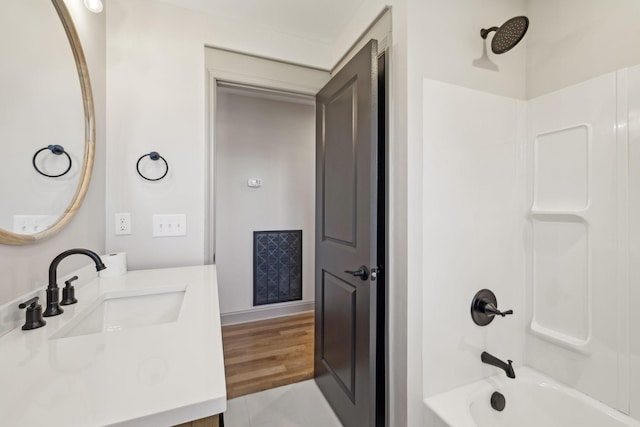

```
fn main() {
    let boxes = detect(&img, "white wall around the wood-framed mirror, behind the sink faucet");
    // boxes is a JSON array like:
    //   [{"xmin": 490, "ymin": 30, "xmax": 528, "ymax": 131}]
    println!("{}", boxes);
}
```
[{"xmin": 0, "ymin": 0, "xmax": 106, "ymax": 303}]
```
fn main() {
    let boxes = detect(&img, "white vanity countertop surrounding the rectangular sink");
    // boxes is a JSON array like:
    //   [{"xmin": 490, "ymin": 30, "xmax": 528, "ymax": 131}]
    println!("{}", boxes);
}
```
[{"xmin": 0, "ymin": 265, "xmax": 226, "ymax": 427}]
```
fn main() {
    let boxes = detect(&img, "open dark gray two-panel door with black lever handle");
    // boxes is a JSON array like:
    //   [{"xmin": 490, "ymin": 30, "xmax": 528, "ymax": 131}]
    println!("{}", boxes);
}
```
[{"xmin": 315, "ymin": 40, "xmax": 383, "ymax": 427}]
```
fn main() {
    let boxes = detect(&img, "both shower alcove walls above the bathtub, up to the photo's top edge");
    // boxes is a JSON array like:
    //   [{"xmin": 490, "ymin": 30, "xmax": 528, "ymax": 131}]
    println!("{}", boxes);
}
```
[{"xmin": 413, "ymin": 0, "xmax": 640, "ymax": 425}]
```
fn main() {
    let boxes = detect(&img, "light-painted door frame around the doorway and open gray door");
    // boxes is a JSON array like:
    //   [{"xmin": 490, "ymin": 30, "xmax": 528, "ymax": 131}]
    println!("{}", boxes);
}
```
[{"xmin": 204, "ymin": 22, "xmax": 390, "ymax": 426}]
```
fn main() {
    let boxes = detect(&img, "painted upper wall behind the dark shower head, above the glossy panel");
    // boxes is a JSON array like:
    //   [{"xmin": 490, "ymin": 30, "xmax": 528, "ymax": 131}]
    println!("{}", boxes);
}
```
[{"xmin": 410, "ymin": 0, "xmax": 529, "ymax": 99}]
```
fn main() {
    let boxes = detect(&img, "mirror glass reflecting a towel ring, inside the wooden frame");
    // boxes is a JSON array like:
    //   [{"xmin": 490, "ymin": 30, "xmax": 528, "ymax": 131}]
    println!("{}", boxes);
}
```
[{"xmin": 0, "ymin": 0, "xmax": 93, "ymax": 244}]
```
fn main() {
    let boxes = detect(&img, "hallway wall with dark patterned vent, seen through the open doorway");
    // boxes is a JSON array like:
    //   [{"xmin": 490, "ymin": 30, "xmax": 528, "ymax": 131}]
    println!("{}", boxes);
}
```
[{"xmin": 215, "ymin": 81, "xmax": 315, "ymax": 324}]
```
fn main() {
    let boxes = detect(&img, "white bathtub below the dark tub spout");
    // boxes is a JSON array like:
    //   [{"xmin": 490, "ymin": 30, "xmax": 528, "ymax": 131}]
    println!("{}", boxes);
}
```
[{"xmin": 425, "ymin": 367, "xmax": 640, "ymax": 427}]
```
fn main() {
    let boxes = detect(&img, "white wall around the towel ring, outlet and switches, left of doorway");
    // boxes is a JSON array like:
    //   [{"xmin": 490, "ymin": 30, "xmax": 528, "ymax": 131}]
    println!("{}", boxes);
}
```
[{"xmin": 106, "ymin": 0, "xmax": 344, "ymax": 269}]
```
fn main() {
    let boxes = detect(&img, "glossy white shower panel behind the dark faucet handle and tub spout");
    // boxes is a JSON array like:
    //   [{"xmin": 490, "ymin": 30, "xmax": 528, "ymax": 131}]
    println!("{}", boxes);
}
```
[{"xmin": 422, "ymin": 79, "xmax": 525, "ymax": 398}]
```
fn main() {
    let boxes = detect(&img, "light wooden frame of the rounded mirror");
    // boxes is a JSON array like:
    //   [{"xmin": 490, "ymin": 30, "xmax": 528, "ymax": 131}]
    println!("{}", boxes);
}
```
[{"xmin": 0, "ymin": 0, "xmax": 96, "ymax": 245}]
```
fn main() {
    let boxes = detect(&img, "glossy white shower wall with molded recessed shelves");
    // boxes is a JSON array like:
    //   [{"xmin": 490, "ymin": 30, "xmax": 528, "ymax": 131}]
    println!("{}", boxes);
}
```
[{"xmin": 525, "ymin": 72, "xmax": 628, "ymax": 412}]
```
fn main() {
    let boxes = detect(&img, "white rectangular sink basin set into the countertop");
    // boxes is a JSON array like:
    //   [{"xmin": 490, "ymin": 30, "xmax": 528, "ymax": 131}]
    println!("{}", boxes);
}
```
[{"xmin": 51, "ymin": 285, "xmax": 187, "ymax": 339}]
